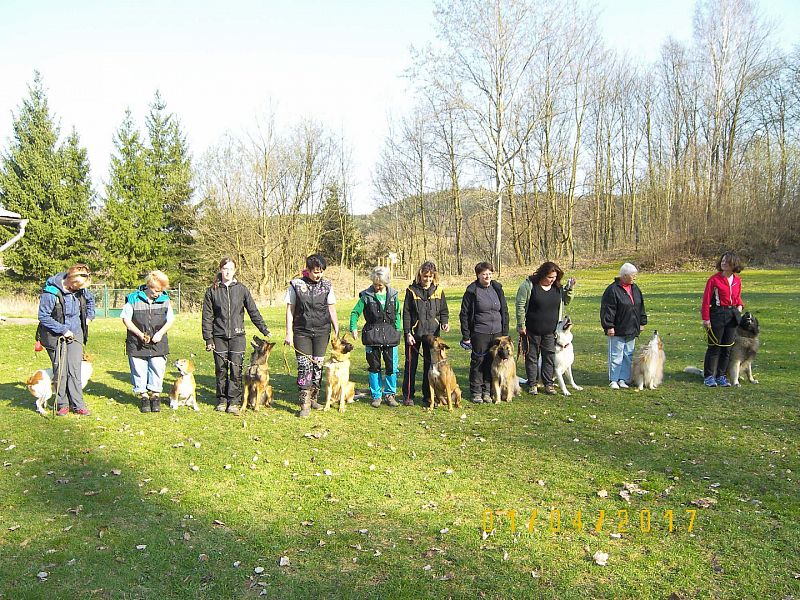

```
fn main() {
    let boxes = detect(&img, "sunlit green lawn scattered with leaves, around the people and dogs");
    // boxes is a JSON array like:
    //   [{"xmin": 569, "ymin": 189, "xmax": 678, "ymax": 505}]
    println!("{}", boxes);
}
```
[{"xmin": 0, "ymin": 269, "xmax": 800, "ymax": 599}]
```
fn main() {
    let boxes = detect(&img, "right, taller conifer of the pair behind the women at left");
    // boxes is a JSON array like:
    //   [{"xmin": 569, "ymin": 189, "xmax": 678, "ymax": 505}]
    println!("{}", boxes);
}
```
[{"xmin": 145, "ymin": 91, "xmax": 198, "ymax": 281}]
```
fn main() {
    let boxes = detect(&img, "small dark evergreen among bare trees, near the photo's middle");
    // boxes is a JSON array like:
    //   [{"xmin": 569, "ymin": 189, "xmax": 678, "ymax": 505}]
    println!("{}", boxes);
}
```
[{"xmin": 319, "ymin": 182, "xmax": 363, "ymax": 266}]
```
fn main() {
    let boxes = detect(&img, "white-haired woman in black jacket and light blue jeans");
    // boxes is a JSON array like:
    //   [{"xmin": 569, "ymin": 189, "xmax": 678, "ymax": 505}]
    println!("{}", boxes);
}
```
[{"xmin": 600, "ymin": 263, "xmax": 647, "ymax": 390}]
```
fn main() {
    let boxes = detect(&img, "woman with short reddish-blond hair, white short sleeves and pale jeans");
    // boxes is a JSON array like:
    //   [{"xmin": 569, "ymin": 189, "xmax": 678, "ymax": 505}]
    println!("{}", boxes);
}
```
[{"xmin": 121, "ymin": 271, "xmax": 175, "ymax": 412}]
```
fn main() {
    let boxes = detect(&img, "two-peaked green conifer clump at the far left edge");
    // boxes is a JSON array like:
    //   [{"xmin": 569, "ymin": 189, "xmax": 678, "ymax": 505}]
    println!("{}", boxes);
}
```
[{"xmin": 0, "ymin": 72, "xmax": 93, "ymax": 279}]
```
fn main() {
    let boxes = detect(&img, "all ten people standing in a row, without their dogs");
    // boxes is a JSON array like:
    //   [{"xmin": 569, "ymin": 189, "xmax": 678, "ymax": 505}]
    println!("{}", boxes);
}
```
[{"xmin": 36, "ymin": 252, "xmax": 743, "ymax": 416}]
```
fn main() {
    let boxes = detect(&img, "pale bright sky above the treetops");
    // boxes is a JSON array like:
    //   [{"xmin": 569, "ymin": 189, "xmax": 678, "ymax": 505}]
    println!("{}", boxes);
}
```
[{"xmin": 0, "ymin": 0, "xmax": 800, "ymax": 212}]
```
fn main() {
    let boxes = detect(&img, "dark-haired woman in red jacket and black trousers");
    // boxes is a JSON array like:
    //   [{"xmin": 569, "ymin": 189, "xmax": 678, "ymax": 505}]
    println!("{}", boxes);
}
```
[{"xmin": 700, "ymin": 252, "xmax": 743, "ymax": 387}]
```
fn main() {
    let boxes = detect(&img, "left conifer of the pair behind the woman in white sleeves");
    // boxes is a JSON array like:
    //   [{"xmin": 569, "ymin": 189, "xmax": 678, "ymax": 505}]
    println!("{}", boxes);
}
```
[{"xmin": 99, "ymin": 110, "xmax": 164, "ymax": 285}]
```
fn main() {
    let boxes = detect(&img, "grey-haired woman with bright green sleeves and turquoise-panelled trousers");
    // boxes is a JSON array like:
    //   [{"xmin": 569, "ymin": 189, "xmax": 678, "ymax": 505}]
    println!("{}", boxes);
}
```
[{"xmin": 350, "ymin": 267, "xmax": 402, "ymax": 408}]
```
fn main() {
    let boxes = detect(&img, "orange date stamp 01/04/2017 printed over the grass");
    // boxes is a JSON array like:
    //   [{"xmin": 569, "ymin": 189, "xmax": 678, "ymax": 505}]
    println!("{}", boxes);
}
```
[{"xmin": 483, "ymin": 508, "xmax": 697, "ymax": 533}]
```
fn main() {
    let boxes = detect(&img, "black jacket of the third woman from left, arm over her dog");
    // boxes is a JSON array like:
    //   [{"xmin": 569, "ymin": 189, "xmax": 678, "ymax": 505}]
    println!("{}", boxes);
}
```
[{"xmin": 203, "ymin": 281, "xmax": 269, "ymax": 343}]
